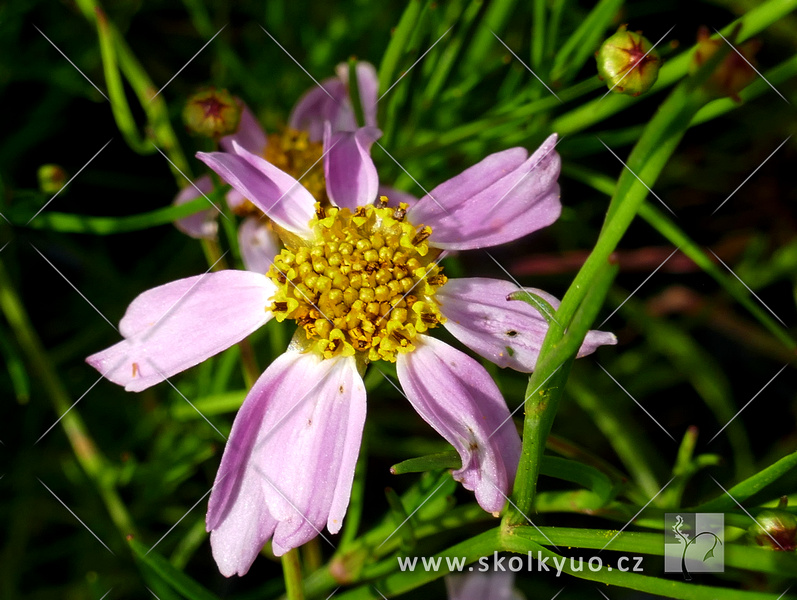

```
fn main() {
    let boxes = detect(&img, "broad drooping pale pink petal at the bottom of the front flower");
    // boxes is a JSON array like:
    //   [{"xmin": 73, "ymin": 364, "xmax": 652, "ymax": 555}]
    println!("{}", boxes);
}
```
[{"xmin": 207, "ymin": 351, "xmax": 365, "ymax": 555}]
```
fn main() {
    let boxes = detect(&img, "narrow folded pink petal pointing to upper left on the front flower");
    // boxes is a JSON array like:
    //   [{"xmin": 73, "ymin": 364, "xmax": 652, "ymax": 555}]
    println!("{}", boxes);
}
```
[{"xmin": 197, "ymin": 142, "xmax": 315, "ymax": 237}]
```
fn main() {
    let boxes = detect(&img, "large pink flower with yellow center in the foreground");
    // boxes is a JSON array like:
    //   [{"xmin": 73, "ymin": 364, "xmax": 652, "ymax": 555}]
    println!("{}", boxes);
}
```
[{"xmin": 87, "ymin": 129, "xmax": 615, "ymax": 576}]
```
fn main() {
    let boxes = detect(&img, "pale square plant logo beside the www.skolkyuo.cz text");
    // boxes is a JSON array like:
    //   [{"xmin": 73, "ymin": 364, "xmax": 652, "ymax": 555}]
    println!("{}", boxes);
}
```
[{"xmin": 664, "ymin": 513, "xmax": 725, "ymax": 581}]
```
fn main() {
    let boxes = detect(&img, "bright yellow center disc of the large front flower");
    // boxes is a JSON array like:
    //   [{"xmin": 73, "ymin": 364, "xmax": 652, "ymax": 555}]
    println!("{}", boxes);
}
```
[{"xmin": 267, "ymin": 196, "xmax": 447, "ymax": 362}]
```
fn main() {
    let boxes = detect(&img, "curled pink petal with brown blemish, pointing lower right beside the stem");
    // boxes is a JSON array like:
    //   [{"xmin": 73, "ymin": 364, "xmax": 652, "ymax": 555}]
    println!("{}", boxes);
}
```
[{"xmin": 396, "ymin": 335, "xmax": 520, "ymax": 512}]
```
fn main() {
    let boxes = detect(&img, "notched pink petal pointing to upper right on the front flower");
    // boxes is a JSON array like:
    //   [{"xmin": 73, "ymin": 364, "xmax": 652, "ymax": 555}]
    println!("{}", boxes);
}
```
[{"xmin": 407, "ymin": 134, "xmax": 562, "ymax": 250}]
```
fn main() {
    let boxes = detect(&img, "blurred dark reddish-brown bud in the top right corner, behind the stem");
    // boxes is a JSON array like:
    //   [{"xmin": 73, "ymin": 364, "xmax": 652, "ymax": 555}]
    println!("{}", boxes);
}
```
[{"xmin": 689, "ymin": 27, "xmax": 761, "ymax": 102}]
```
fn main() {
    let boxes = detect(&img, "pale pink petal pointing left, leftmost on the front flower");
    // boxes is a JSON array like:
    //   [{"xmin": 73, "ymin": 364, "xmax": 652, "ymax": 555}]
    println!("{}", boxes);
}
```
[{"xmin": 86, "ymin": 271, "xmax": 276, "ymax": 392}]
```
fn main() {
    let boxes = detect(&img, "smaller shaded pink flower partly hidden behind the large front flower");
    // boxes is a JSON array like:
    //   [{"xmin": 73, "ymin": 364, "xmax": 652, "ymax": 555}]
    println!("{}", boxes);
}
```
[{"xmin": 174, "ymin": 62, "xmax": 379, "ymax": 273}]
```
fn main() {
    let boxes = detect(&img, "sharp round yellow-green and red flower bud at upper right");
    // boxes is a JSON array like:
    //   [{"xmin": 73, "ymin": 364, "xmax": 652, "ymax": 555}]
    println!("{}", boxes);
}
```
[{"xmin": 595, "ymin": 25, "xmax": 661, "ymax": 96}]
